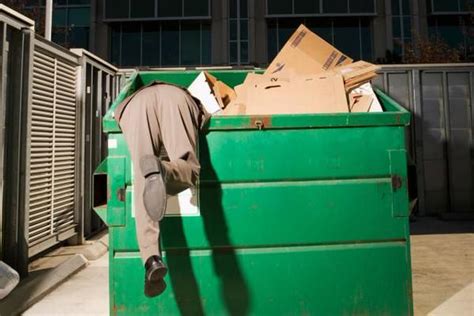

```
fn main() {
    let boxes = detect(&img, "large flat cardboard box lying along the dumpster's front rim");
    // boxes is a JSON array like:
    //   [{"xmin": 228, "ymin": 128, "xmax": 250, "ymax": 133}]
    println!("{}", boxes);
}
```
[{"xmin": 231, "ymin": 75, "xmax": 349, "ymax": 115}]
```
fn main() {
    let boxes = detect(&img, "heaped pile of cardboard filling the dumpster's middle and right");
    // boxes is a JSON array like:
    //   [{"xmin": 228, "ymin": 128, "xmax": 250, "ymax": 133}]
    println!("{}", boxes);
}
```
[{"xmin": 216, "ymin": 25, "xmax": 383, "ymax": 115}]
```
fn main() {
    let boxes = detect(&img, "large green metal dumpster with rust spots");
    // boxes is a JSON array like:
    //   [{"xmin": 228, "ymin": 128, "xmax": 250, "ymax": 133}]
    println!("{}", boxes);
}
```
[{"xmin": 94, "ymin": 71, "xmax": 413, "ymax": 315}]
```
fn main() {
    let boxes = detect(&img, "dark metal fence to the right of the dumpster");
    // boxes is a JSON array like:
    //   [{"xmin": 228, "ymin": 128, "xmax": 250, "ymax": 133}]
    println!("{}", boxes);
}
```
[{"xmin": 375, "ymin": 64, "xmax": 474, "ymax": 217}]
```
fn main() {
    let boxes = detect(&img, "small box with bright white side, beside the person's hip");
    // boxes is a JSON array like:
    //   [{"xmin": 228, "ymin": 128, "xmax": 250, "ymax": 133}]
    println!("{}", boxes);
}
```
[{"xmin": 188, "ymin": 71, "xmax": 236, "ymax": 114}]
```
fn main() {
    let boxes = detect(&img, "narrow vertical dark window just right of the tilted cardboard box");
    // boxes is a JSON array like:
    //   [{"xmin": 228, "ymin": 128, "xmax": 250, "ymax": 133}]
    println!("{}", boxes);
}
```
[{"xmin": 392, "ymin": 0, "xmax": 412, "ymax": 58}]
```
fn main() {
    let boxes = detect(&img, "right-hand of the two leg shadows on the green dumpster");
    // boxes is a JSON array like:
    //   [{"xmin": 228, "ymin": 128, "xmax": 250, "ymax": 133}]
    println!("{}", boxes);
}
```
[{"xmin": 199, "ymin": 137, "xmax": 250, "ymax": 316}]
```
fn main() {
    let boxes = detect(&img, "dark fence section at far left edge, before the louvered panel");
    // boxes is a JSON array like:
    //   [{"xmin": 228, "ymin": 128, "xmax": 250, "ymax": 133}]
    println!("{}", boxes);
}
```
[{"xmin": 0, "ymin": 5, "xmax": 34, "ymax": 275}]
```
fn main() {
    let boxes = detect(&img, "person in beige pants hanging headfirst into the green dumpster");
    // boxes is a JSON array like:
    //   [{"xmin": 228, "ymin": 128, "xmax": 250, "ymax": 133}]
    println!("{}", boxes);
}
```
[{"xmin": 114, "ymin": 82, "xmax": 209, "ymax": 297}]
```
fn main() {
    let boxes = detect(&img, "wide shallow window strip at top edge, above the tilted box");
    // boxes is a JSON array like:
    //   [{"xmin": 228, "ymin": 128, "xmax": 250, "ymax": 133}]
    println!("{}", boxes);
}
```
[{"xmin": 267, "ymin": 0, "xmax": 376, "ymax": 17}]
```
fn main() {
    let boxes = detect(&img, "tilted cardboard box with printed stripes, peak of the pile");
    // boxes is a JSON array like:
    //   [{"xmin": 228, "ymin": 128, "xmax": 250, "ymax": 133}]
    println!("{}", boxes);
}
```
[{"xmin": 265, "ymin": 25, "xmax": 352, "ymax": 77}]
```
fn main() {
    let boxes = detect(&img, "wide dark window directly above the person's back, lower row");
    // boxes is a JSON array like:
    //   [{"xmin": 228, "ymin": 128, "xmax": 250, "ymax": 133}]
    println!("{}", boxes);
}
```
[{"xmin": 110, "ymin": 21, "xmax": 211, "ymax": 67}]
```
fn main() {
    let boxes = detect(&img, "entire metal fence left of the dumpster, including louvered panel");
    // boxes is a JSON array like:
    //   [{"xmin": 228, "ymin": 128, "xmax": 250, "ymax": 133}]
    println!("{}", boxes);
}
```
[{"xmin": 0, "ymin": 5, "xmax": 119, "ymax": 275}]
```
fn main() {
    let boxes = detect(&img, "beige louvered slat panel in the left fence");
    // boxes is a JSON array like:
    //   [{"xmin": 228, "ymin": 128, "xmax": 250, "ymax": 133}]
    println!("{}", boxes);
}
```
[{"xmin": 28, "ymin": 47, "xmax": 79, "ymax": 256}]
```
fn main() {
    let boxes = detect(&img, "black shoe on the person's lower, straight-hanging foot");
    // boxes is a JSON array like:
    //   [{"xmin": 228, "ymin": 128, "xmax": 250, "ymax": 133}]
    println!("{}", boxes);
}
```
[{"xmin": 145, "ymin": 256, "xmax": 168, "ymax": 297}]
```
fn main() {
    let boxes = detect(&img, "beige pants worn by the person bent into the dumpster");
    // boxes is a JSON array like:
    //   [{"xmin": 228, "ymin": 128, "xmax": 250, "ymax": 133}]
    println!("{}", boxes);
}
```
[{"xmin": 120, "ymin": 84, "xmax": 201, "ymax": 262}]
